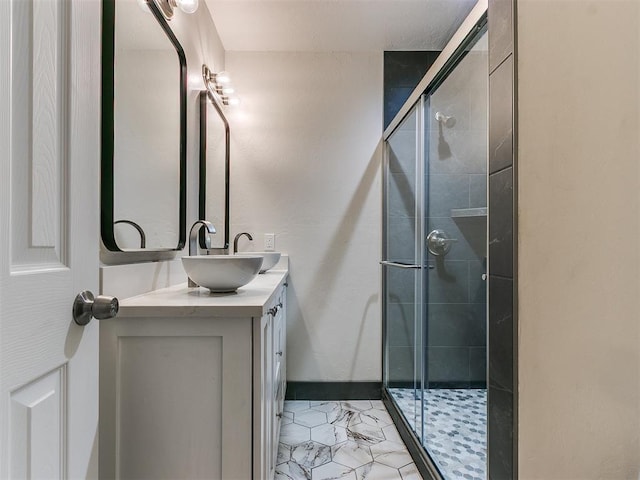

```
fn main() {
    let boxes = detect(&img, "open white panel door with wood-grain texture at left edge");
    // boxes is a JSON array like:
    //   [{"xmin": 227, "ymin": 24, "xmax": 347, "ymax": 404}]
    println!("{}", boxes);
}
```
[{"xmin": 0, "ymin": 0, "xmax": 101, "ymax": 480}]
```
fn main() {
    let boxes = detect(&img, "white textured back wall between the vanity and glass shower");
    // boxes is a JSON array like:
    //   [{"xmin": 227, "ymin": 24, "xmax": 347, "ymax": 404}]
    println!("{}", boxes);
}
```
[{"xmin": 226, "ymin": 52, "xmax": 382, "ymax": 381}]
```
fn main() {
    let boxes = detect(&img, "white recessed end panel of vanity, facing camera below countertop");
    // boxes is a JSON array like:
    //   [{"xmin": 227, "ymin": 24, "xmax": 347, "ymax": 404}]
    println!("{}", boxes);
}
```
[{"xmin": 99, "ymin": 316, "xmax": 251, "ymax": 480}]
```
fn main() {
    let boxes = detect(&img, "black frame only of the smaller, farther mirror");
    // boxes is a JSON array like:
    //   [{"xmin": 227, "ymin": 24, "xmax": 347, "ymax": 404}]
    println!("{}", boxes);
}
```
[{"xmin": 198, "ymin": 90, "xmax": 231, "ymax": 249}]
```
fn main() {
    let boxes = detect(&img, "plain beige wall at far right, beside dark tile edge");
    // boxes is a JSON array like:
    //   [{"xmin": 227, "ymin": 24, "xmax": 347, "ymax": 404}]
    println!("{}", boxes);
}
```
[{"xmin": 517, "ymin": 0, "xmax": 640, "ymax": 480}]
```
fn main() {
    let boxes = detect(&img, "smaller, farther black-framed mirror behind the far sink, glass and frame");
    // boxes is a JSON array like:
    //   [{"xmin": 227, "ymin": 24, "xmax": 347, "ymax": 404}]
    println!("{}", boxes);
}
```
[{"xmin": 198, "ymin": 91, "xmax": 229, "ymax": 249}]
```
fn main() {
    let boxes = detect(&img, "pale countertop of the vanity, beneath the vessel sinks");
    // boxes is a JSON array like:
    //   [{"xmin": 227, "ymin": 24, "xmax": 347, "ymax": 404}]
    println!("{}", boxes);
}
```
[{"xmin": 118, "ymin": 266, "xmax": 289, "ymax": 317}]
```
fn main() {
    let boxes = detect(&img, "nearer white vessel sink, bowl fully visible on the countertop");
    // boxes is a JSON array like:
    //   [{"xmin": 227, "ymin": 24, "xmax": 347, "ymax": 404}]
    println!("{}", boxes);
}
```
[{"xmin": 182, "ymin": 254, "xmax": 263, "ymax": 293}]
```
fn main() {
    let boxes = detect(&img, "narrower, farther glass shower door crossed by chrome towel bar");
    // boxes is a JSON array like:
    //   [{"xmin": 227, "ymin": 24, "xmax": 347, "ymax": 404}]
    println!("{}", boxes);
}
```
[{"xmin": 381, "ymin": 101, "xmax": 424, "ymax": 438}]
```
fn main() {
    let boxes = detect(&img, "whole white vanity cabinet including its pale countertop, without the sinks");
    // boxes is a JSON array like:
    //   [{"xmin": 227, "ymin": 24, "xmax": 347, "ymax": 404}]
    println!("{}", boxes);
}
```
[{"xmin": 99, "ymin": 271, "xmax": 287, "ymax": 480}]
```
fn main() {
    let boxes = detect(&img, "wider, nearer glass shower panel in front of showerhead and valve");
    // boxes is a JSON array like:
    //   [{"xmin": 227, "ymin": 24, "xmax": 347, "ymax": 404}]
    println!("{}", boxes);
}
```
[{"xmin": 422, "ymin": 33, "xmax": 489, "ymax": 480}]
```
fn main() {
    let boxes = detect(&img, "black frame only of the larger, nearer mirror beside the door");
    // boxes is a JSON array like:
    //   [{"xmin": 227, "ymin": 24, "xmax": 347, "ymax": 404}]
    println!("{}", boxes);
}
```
[{"xmin": 100, "ymin": 0, "xmax": 187, "ymax": 253}]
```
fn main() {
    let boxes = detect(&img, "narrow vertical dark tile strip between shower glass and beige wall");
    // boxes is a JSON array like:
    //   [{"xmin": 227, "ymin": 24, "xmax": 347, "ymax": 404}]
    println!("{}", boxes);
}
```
[{"xmin": 487, "ymin": 0, "xmax": 518, "ymax": 480}]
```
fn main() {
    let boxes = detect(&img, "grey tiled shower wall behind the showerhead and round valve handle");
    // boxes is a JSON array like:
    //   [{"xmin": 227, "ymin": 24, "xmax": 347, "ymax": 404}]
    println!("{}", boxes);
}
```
[{"xmin": 425, "ymin": 37, "xmax": 488, "ymax": 388}]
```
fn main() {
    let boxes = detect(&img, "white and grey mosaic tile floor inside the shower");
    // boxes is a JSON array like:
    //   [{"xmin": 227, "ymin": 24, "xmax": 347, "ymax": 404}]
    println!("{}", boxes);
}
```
[{"xmin": 389, "ymin": 388, "xmax": 487, "ymax": 480}]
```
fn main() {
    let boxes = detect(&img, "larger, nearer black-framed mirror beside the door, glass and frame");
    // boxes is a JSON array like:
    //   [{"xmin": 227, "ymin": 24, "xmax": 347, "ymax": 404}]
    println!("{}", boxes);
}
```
[{"xmin": 101, "ymin": 0, "xmax": 187, "ymax": 252}]
